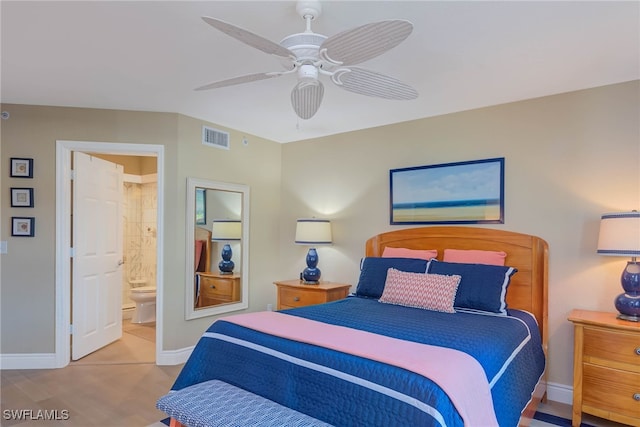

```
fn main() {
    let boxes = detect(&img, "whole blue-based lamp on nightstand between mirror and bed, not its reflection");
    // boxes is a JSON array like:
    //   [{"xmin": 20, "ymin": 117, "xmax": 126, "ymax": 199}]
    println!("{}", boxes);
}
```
[{"xmin": 296, "ymin": 218, "xmax": 331, "ymax": 285}]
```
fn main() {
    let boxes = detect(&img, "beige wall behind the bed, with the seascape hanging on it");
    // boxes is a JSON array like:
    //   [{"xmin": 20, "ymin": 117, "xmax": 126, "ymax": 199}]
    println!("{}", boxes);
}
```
[{"xmin": 281, "ymin": 81, "xmax": 640, "ymax": 392}]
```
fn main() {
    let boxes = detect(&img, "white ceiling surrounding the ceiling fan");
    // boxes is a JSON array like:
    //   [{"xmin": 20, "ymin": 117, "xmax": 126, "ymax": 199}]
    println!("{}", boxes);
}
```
[{"xmin": 0, "ymin": 0, "xmax": 640, "ymax": 142}]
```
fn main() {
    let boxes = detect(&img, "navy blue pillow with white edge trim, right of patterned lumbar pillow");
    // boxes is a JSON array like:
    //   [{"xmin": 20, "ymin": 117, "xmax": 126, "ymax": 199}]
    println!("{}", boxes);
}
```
[{"xmin": 427, "ymin": 260, "xmax": 518, "ymax": 315}]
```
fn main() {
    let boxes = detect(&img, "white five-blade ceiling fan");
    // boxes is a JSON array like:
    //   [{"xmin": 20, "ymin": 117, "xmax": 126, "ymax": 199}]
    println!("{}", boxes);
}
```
[{"xmin": 195, "ymin": 0, "xmax": 418, "ymax": 119}]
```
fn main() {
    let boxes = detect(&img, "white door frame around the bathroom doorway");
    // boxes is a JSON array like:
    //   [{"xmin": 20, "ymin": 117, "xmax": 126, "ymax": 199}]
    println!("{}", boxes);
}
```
[{"xmin": 55, "ymin": 140, "xmax": 164, "ymax": 368}]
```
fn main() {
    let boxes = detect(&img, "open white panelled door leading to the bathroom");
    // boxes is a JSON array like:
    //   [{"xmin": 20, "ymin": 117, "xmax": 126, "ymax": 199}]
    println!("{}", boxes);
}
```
[{"xmin": 71, "ymin": 152, "xmax": 124, "ymax": 360}]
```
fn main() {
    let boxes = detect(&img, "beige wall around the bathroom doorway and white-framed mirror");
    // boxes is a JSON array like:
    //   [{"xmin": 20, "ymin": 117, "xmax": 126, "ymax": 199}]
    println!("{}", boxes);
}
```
[{"xmin": 0, "ymin": 104, "xmax": 281, "ymax": 354}]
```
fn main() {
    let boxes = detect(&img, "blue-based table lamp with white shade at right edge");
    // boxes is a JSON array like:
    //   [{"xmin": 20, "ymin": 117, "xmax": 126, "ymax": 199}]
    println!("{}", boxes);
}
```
[{"xmin": 598, "ymin": 210, "xmax": 640, "ymax": 322}]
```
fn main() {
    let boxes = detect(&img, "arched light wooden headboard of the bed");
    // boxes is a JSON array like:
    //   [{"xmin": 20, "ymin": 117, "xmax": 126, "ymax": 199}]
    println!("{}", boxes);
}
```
[{"xmin": 365, "ymin": 226, "xmax": 549, "ymax": 352}]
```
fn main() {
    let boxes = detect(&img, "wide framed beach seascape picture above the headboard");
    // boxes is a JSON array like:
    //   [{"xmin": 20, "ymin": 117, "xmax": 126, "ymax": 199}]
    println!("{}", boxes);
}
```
[{"xmin": 389, "ymin": 157, "xmax": 504, "ymax": 225}]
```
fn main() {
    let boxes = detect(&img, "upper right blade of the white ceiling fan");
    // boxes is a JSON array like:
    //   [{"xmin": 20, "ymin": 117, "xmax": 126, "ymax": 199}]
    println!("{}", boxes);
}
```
[{"xmin": 320, "ymin": 19, "xmax": 413, "ymax": 65}]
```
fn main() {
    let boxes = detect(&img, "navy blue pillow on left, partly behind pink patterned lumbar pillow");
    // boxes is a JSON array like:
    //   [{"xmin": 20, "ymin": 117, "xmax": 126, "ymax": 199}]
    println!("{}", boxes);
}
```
[{"xmin": 356, "ymin": 257, "xmax": 427, "ymax": 299}]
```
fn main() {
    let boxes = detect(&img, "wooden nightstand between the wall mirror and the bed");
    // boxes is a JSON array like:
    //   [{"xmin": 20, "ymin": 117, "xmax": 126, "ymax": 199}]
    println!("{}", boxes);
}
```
[{"xmin": 273, "ymin": 280, "xmax": 351, "ymax": 310}]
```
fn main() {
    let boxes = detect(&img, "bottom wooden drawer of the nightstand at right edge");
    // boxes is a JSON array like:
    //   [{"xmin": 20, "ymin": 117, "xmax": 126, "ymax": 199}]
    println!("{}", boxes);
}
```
[{"xmin": 582, "ymin": 363, "xmax": 640, "ymax": 421}]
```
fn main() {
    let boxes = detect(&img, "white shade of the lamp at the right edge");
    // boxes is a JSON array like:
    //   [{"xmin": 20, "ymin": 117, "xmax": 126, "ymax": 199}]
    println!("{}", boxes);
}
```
[{"xmin": 598, "ymin": 211, "xmax": 640, "ymax": 257}]
